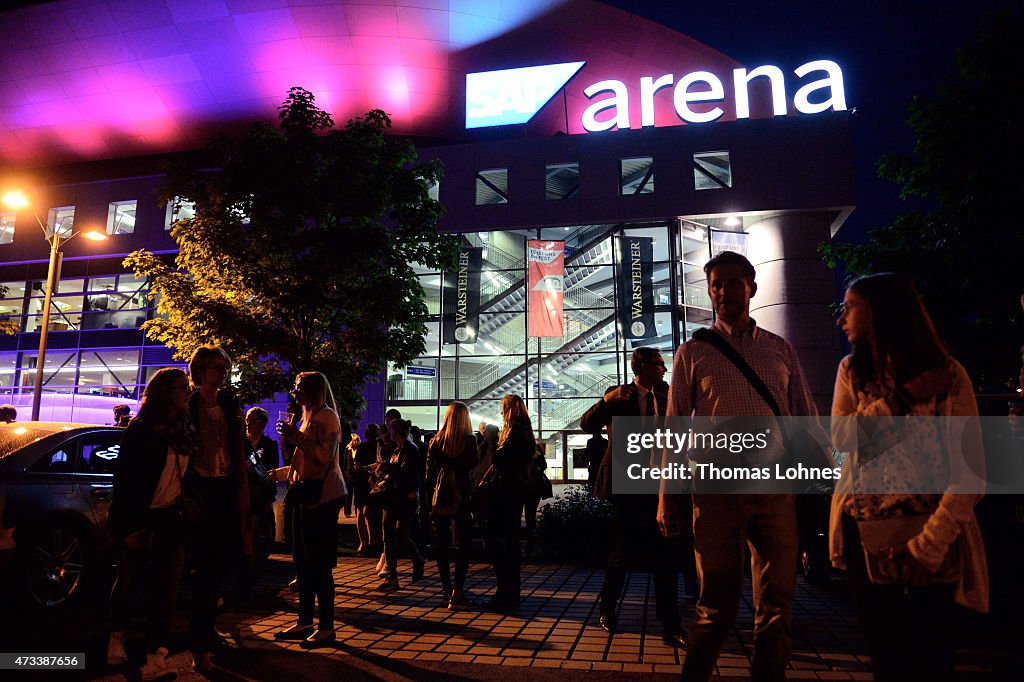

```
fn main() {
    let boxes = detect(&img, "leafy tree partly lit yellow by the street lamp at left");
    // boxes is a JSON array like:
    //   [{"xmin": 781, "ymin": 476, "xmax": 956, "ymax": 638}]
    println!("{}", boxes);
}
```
[{"xmin": 125, "ymin": 88, "xmax": 457, "ymax": 418}]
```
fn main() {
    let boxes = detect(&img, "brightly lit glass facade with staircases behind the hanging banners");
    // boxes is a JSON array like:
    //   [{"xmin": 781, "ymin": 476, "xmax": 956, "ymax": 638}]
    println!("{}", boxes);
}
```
[{"xmin": 386, "ymin": 220, "xmax": 745, "ymax": 480}]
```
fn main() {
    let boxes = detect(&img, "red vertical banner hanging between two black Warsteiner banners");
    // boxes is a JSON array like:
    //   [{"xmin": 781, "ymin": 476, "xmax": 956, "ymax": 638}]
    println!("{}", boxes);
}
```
[{"xmin": 526, "ymin": 240, "xmax": 565, "ymax": 338}]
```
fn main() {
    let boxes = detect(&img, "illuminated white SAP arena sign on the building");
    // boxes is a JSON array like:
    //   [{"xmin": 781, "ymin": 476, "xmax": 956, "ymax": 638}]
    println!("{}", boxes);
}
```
[{"xmin": 466, "ymin": 59, "xmax": 847, "ymax": 132}]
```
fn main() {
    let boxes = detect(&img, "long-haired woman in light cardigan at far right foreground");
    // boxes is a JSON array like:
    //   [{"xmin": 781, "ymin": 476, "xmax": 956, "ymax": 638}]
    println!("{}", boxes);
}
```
[{"xmin": 829, "ymin": 272, "xmax": 988, "ymax": 680}]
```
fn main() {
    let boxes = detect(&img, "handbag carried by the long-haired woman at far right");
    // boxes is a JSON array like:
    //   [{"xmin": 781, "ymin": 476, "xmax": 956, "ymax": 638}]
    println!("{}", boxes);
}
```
[{"xmin": 857, "ymin": 514, "xmax": 961, "ymax": 585}]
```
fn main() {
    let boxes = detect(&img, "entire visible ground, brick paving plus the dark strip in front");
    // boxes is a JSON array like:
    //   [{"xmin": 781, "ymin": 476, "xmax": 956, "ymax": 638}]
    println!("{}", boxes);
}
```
[{"xmin": 81, "ymin": 555, "xmax": 1005, "ymax": 680}]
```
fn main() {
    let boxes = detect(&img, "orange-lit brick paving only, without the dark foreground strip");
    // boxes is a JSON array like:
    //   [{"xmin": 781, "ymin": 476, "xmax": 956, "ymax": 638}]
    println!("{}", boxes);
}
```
[{"xmin": 219, "ymin": 557, "xmax": 871, "ymax": 680}]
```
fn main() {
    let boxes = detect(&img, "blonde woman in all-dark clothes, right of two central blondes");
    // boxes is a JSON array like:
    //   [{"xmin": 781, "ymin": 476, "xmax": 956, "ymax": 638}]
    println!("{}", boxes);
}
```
[{"xmin": 485, "ymin": 393, "xmax": 537, "ymax": 612}]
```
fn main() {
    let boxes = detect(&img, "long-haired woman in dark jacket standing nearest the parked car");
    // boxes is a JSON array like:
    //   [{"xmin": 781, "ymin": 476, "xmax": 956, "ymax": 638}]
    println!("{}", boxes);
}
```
[{"xmin": 106, "ymin": 368, "xmax": 199, "ymax": 680}]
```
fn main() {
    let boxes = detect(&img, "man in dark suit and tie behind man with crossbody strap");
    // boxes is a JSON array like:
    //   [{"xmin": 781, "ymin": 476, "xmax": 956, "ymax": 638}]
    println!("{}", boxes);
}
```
[{"xmin": 580, "ymin": 348, "xmax": 692, "ymax": 647}]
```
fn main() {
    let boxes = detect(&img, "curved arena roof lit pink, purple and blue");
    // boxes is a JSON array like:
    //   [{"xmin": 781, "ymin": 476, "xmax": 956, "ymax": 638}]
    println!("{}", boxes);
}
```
[{"xmin": 0, "ymin": 0, "xmax": 741, "ymax": 168}]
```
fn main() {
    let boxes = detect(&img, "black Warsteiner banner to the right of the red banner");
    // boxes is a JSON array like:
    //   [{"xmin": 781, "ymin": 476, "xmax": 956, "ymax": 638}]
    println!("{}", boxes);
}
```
[{"xmin": 616, "ymin": 237, "xmax": 656, "ymax": 339}]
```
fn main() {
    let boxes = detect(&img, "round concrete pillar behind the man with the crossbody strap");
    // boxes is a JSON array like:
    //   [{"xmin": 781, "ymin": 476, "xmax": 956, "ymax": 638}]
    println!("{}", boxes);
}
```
[{"xmin": 746, "ymin": 213, "xmax": 840, "ymax": 414}]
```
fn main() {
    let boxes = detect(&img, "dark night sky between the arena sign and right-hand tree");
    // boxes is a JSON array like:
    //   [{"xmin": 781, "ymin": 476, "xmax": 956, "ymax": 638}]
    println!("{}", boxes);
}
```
[{"xmin": 603, "ymin": 0, "xmax": 1009, "ymax": 241}]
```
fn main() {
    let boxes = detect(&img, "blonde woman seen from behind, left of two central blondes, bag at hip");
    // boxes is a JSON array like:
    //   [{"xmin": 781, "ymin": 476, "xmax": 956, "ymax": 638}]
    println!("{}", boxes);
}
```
[{"xmin": 427, "ymin": 401, "xmax": 477, "ymax": 610}]
